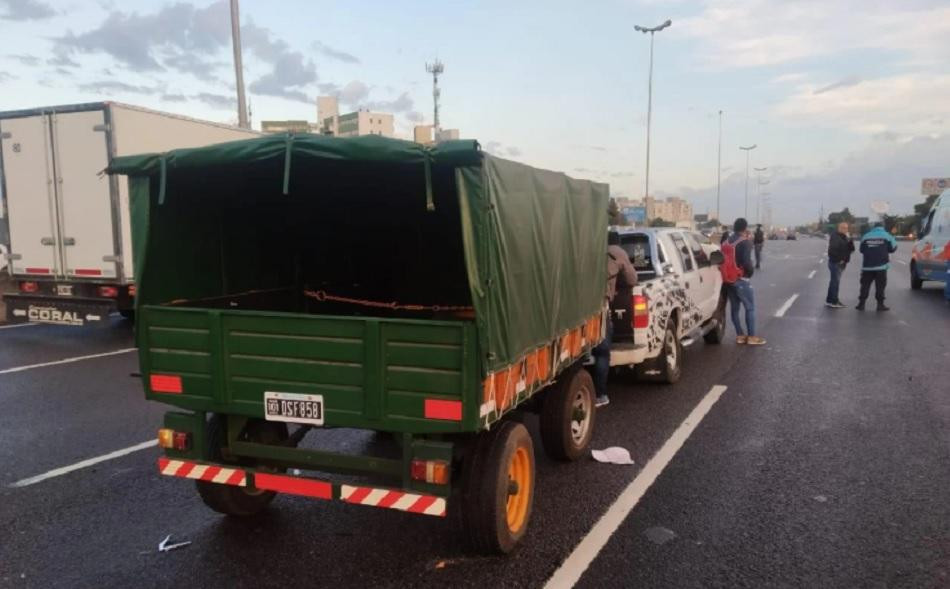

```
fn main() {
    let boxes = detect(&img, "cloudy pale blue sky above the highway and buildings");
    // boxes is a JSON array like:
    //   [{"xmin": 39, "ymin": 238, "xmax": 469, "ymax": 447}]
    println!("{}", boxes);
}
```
[{"xmin": 0, "ymin": 0, "xmax": 950, "ymax": 225}]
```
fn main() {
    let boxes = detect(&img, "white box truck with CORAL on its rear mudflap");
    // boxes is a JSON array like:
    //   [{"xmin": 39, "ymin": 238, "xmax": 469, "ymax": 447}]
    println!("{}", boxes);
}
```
[{"xmin": 0, "ymin": 102, "xmax": 259, "ymax": 325}]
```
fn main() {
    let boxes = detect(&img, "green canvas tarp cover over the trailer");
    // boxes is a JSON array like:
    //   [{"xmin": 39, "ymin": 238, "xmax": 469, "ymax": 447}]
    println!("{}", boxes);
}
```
[{"xmin": 108, "ymin": 134, "xmax": 608, "ymax": 373}]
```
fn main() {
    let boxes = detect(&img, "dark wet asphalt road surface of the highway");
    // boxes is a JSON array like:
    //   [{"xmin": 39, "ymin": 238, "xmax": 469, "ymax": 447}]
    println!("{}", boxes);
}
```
[{"xmin": 0, "ymin": 239, "xmax": 950, "ymax": 587}]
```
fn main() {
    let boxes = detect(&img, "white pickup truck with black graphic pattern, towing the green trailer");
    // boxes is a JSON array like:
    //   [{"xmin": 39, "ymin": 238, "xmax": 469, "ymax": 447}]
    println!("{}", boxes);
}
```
[{"xmin": 610, "ymin": 227, "xmax": 726, "ymax": 384}]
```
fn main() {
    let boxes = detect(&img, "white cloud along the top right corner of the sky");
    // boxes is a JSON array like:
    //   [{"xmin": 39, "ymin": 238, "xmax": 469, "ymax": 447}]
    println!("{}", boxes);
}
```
[{"xmin": 670, "ymin": 0, "xmax": 950, "ymax": 69}]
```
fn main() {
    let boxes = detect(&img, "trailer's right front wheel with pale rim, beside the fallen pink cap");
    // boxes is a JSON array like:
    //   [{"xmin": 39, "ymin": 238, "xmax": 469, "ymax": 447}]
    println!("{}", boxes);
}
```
[{"xmin": 541, "ymin": 366, "xmax": 596, "ymax": 462}]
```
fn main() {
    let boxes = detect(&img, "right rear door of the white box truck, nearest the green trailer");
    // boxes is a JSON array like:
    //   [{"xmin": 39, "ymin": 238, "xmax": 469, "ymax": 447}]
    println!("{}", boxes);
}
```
[{"xmin": 49, "ymin": 110, "xmax": 116, "ymax": 278}]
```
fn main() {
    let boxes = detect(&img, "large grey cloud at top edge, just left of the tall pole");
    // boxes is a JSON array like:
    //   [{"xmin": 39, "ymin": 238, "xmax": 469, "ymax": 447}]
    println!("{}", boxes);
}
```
[{"xmin": 54, "ymin": 0, "xmax": 230, "ymax": 71}]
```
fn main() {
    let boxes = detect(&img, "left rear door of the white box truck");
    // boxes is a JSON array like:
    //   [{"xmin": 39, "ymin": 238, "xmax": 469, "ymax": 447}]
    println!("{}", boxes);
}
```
[{"xmin": 0, "ymin": 114, "xmax": 62, "ymax": 275}]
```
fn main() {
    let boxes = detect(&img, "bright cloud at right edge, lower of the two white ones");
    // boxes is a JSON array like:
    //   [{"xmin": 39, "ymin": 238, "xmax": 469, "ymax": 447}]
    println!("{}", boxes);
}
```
[{"xmin": 774, "ymin": 73, "xmax": 950, "ymax": 137}]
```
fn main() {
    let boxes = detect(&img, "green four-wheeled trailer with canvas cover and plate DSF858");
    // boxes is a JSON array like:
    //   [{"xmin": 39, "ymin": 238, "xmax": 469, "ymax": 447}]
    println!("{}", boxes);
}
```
[{"xmin": 110, "ymin": 134, "xmax": 608, "ymax": 553}]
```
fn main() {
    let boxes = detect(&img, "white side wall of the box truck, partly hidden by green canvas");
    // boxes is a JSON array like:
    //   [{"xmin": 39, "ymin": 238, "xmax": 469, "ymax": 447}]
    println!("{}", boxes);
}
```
[{"xmin": 109, "ymin": 104, "xmax": 260, "ymax": 281}]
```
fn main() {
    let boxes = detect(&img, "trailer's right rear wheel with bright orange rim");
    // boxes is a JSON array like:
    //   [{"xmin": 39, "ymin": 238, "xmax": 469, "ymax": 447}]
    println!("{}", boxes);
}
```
[{"xmin": 461, "ymin": 421, "xmax": 535, "ymax": 554}]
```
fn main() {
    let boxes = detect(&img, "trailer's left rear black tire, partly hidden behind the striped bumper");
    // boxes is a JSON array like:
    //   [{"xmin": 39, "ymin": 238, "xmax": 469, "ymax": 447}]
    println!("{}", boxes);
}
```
[{"xmin": 195, "ymin": 414, "xmax": 288, "ymax": 517}]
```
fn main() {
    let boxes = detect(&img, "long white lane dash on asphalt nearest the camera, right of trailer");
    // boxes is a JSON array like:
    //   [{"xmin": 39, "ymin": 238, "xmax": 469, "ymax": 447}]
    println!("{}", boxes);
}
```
[{"xmin": 544, "ymin": 385, "xmax": 726, "ymax": 589}]
